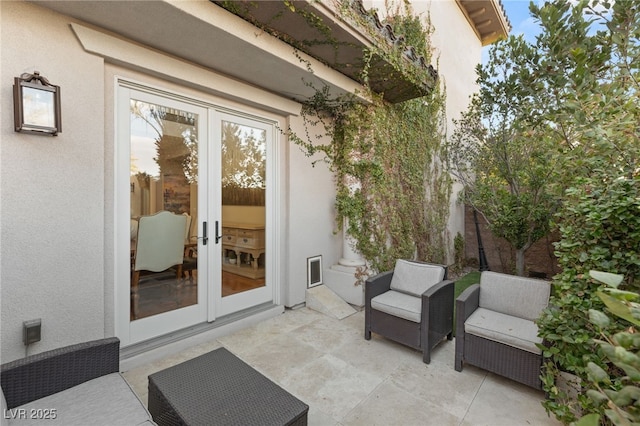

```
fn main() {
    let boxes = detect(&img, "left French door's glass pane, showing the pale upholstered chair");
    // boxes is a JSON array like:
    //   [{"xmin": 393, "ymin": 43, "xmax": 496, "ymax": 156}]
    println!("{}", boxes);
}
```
[{"xmin": 130, "ymin": 99, "xmax": 198, "ymax": 320}]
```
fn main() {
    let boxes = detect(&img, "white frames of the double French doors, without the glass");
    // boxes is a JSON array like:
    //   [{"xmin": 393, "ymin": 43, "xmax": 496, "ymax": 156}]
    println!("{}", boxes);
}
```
[{"xmin": 113, "ymin": 77, "xmax": 286, "ymax": 347}]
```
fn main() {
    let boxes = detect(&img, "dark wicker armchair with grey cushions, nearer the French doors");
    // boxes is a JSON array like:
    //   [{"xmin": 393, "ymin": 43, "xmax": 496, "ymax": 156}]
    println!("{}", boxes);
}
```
[{"xmin": 364, "ymin": 259, "xmax": 455, "ymax": 364}]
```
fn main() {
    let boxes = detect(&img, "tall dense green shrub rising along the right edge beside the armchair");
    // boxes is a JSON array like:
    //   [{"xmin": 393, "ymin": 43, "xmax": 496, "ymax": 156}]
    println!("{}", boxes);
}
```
[{"xmin": 530, "ymin": 0, "xmax": 640, "ymax": 423}]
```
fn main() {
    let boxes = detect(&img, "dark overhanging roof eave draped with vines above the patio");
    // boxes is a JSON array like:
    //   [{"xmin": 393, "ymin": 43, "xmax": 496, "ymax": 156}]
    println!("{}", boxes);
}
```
[{"xmin": 211, "ymin": 0, "xmax": 438, "ymax": 103}]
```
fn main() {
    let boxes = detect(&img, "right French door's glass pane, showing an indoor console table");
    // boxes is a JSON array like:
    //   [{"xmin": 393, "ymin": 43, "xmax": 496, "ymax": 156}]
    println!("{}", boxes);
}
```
[{"xmin": 221, "ymin": 121, "xmax": 267, "ymax": 297}]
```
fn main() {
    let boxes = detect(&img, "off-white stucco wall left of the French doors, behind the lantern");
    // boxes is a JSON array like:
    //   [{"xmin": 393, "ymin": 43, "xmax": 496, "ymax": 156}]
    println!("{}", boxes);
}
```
[{"xmin": 0, "ymin": 1, "xmax": 105, "ymax": 362}]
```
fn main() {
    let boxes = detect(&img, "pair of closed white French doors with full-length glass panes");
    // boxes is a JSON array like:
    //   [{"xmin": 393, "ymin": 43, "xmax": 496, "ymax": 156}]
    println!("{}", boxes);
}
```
[{"xmin": 115, "ymin": 81, "xmax": 275, "ymax": 346}]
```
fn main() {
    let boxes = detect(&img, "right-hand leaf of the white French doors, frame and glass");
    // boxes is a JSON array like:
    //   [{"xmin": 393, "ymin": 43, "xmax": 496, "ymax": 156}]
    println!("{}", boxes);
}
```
[{"xmin": 212, "ymin": 110, "xmax": 275, "ymax": 315}]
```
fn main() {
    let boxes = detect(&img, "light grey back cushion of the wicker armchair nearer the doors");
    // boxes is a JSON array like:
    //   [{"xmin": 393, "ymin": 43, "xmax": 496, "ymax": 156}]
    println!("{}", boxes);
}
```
[{"xmin": 391, "ymin": 259, "xmax": 444, "ymax": 297}]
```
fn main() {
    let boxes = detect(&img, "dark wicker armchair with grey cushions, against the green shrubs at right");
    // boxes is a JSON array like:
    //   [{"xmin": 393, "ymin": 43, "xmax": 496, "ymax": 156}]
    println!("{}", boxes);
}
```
[{"xmin": 455, "ymin": 271, "xmax": 551, "ymax": 389}]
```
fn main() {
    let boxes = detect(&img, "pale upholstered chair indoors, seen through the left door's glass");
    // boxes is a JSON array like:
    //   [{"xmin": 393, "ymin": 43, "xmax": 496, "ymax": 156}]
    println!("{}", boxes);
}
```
[{"xmin": 131, "ymin": 211, "xmax": 187, "ymax": 318}]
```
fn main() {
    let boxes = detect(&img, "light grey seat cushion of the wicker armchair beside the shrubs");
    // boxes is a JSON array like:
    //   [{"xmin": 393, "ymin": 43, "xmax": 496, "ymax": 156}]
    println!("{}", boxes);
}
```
[{"xmin": 464, "ymin": 308, "xmax": 542, "ymax": 354}]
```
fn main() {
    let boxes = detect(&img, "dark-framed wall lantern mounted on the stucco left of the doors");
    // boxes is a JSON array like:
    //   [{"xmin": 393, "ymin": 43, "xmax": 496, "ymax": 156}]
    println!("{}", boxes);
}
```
[{"xmin": 13, "ymin": 71, "xmax": 62, "ymax": 136}]
